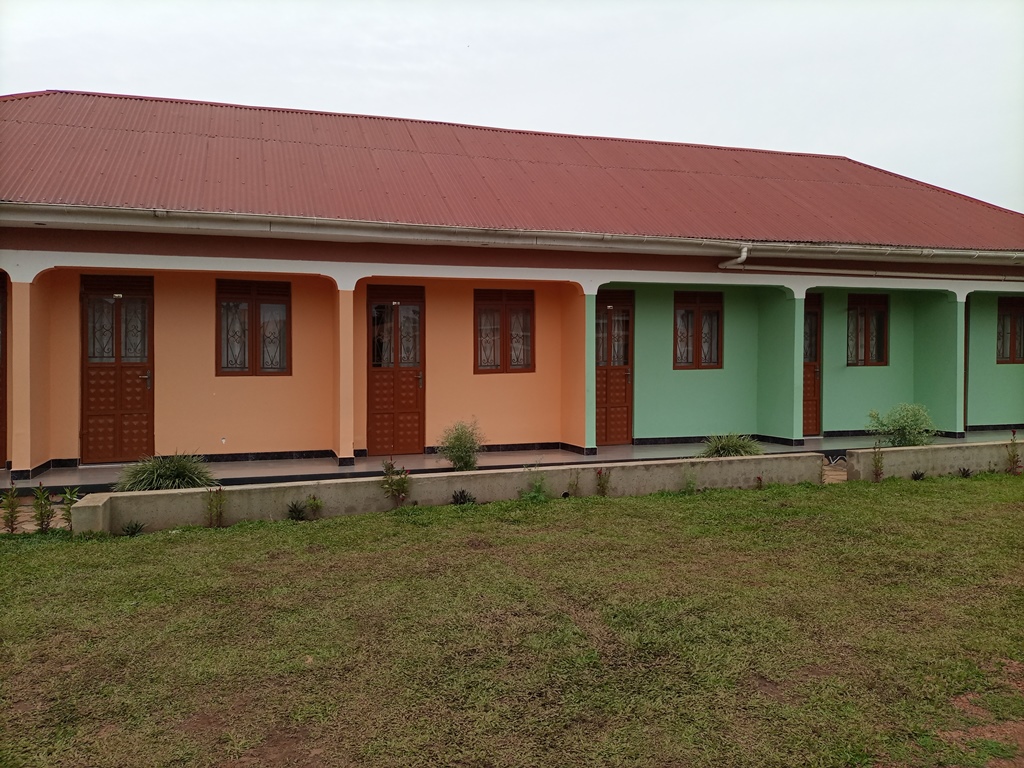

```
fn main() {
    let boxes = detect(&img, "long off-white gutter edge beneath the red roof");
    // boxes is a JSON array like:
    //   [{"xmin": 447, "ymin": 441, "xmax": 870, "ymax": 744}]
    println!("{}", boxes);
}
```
[{"xmin": 0, "ymin": 202, "xmax": 1024, "ymax": 266}]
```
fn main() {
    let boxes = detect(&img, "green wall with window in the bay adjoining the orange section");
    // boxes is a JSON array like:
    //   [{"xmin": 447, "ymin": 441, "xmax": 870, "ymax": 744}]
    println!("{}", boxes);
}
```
[{"xmin": 622, "ymin": 286, "xmax": 803, "ymax": 438}]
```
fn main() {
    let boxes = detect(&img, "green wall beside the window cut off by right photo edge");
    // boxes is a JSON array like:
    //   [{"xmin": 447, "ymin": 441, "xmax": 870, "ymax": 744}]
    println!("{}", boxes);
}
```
[{"xmin": 967, "ymin": 293, "xmax": 1024, "ymax": 426}]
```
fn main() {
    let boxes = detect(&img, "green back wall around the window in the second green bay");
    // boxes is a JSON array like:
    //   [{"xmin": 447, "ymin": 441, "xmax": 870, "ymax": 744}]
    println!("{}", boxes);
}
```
[{"xmin": 821, "ymin": 290, "xmax": 914, "ymax": 432}]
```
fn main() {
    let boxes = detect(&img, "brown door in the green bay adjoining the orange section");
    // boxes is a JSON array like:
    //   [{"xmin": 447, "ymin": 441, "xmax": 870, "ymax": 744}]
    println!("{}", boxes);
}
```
[{"xmin": 595, "ymin": 291, "xmax": 633, "ymax": 445}]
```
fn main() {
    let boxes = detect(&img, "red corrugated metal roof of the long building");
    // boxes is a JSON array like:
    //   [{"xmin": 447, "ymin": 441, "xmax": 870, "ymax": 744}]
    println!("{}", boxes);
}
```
[{"xmin": 0, "ymin": 91, "xmax": 1024, "ymax": 250}]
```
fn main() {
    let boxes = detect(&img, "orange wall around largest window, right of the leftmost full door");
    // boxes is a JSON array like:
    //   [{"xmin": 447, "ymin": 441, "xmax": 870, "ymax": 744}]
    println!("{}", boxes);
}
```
[{"xmin": 154, "ymin": 272, "xmax": 337, "ymax": 454}]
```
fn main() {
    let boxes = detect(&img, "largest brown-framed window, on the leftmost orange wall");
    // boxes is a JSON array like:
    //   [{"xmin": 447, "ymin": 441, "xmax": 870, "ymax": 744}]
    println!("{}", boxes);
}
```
[{"xmin": 217, "ymin": 280, "xmax": 292, "ymax": 376}]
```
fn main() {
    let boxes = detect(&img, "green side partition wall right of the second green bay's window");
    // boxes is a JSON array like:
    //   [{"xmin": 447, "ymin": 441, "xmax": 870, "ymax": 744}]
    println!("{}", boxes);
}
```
[{"xmin": 911, "ymin": 293, "xmax": 964, "ymax": 432}]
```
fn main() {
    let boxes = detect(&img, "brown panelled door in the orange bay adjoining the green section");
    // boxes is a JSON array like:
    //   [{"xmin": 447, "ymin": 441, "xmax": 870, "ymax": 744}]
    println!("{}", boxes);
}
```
[{"xmin": 367, "ymin": 286, "xmax": 426, "ymax": 456}]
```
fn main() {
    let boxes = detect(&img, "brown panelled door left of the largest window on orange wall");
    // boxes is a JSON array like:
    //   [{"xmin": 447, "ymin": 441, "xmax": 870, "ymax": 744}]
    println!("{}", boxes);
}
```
[{"xmin": 82, "ymin": 275, "xmax": 156, "ymax": 464}]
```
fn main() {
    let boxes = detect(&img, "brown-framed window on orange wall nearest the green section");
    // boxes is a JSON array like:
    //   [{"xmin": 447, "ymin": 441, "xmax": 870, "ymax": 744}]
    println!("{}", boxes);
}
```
[{"xmin": 473, "ymin": 290, "xmax": 535, "ymax": 374}]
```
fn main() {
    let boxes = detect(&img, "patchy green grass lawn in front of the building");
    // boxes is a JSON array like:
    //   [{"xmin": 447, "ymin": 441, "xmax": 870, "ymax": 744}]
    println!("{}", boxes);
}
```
[{"xmin": 0, "ymin": 475, "xmax": 1024, "ymax": 768}]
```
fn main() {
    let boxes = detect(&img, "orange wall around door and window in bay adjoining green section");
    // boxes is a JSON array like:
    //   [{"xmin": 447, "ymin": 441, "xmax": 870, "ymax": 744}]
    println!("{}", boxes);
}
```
[{"xmin": 353, "ymin": 279, "xmax": 584, "ymax": 449}]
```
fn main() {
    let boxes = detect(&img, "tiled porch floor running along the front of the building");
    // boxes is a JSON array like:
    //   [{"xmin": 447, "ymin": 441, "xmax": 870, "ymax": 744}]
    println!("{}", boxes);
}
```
[{"xmin": 0, "ymin": 430, "xmax": 1010, "ymax": 493}]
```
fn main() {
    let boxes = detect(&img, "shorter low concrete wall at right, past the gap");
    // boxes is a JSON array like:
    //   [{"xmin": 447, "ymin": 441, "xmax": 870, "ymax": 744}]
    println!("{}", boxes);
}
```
[{"xmin": 846, "ymin": 442, "xmax": 1011, "ymax": 480}]
